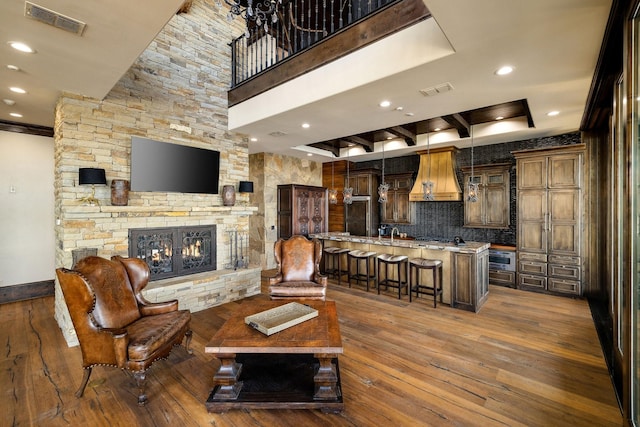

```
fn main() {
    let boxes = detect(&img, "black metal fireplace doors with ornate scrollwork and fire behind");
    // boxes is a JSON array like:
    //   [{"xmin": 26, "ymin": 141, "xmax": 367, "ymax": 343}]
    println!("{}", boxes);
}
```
[{"xmin": 129, "ymin": 225, "xmax": 216, "ymax": 280}]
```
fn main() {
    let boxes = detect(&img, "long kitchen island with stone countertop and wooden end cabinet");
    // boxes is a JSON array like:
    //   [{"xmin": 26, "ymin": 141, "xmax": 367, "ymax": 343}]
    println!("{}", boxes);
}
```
[{"xmin": 310, "ymin": 232, "xmax": 490, "ymax": 312}]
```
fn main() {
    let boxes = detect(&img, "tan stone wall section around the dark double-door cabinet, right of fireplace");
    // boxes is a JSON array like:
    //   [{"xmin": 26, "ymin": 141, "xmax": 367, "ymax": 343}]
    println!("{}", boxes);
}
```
[{"xmin": 249, "ymin": 153, "xmax": 322, "ymax": 269}]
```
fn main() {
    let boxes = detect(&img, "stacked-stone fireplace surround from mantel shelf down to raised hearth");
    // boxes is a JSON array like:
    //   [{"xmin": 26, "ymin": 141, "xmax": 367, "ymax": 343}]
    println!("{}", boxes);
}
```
[{"xmin": 55, "ymin": 204, "xmax": 262, "ymax": 346}]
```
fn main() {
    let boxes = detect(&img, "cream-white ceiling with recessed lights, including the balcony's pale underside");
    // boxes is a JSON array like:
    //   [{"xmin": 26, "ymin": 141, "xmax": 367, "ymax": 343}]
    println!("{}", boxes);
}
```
[{"xmin": 0, "ymin": 0, "xmax": 611, "ymax": 161}]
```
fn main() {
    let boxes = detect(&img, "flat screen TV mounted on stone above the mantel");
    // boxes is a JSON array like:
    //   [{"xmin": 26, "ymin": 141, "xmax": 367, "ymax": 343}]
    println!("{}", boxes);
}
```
[{"xmin": 131, "ymin": 136, "xmax": 220, "ymax": 194}]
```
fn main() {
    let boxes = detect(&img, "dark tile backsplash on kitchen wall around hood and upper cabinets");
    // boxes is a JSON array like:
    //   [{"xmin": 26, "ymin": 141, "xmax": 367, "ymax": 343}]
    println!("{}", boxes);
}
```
[{"xmin": 356, "ymin": 132, "xmax": 581, "ymax": 245}]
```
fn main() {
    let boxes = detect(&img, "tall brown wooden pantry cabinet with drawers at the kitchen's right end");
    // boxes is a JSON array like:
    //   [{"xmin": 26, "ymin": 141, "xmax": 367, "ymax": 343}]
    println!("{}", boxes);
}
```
[{"xmin": 514, "ymin": 144, "xmax": 584, "ymax": 295}]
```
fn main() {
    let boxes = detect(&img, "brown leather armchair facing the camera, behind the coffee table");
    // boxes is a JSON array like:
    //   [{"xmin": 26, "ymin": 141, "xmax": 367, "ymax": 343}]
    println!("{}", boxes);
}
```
[{"xmin": 269, "ymin": 236, "xmax": 327, "ymax": 300}]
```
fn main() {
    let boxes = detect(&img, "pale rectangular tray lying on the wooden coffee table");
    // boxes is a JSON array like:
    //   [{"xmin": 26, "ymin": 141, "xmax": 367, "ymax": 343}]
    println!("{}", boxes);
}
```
[{"xmin": 244, "ymin": 302, "xmax": 318, "ymax": 336}]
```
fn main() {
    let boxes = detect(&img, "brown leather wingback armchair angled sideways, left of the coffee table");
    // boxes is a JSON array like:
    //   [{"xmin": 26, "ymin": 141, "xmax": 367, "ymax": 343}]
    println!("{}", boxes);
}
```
[{"xmin": 56, "ymin": 256, "xmax": 192, "ymax": 406}]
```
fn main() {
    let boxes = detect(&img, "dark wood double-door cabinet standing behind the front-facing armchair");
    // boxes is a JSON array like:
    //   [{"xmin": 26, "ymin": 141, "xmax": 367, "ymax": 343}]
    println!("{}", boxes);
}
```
[{"xmin": 278, "ymin": 184, "xmax": 329, "ymax": 239}]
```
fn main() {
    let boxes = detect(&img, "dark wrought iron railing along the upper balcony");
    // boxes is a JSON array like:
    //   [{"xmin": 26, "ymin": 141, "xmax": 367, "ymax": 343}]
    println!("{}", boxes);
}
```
[{"xmin": 231, "ymin": 0, "xmax": 398, "ymax": 88}]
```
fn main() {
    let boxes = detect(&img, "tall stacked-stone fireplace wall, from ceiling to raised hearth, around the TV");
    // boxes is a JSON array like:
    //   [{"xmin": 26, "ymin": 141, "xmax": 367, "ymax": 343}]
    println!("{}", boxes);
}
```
[{"xmin": 54, "ymin": 0, "xmax": 261, "ymax": 344}]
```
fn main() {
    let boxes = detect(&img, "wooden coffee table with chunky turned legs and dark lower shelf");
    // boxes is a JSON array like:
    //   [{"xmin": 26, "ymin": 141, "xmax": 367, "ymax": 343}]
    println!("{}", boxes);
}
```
[{"xmin": 205, "ymin": 299, "xmax": 344, "ymax": 412}]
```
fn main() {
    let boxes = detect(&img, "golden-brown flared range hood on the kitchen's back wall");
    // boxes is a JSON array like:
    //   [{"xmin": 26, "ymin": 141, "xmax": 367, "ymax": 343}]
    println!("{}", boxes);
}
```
[{"xmin": 409, "ymin": 147, "xmax": 462, "ymax": 202}]
